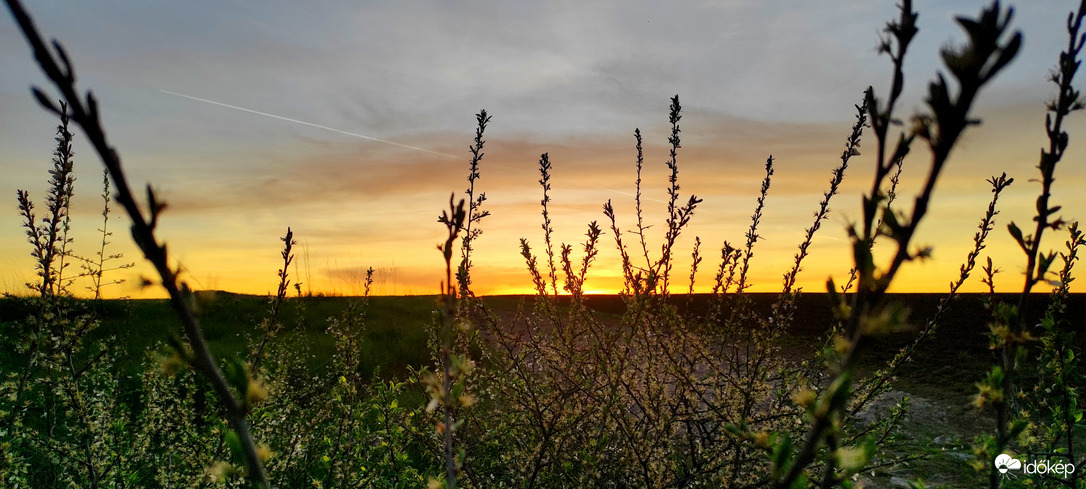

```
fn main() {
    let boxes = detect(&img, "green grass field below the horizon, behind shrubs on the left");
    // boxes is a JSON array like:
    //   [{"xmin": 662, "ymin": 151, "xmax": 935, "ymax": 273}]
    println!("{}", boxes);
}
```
[{"xmin": 0, "ymin": 292, "xmax": 434, "ymax": 377}]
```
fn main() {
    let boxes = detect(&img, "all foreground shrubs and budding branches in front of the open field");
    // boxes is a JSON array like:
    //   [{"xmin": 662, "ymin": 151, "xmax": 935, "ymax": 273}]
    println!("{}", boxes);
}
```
[{"xmin": 2, "ymin": 0, "xmax": 1086, "ymax": 488}]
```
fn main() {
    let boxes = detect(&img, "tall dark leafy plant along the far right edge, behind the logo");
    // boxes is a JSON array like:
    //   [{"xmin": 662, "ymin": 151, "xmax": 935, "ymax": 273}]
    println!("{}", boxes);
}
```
[{"xmin": 976, "ymin": 2, "xmax": 1086, "ymax": 488}]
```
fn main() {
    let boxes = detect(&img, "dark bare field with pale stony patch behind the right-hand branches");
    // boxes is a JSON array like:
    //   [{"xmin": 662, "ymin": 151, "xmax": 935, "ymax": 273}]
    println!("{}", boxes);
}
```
[{"xmin": 477, "ymin": 294, "xmax": 1086, "ymax": 488}]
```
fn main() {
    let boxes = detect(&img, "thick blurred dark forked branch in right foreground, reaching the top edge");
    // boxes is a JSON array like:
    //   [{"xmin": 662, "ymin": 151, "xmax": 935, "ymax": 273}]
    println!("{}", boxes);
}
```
[{"xmin": 771, "ymin": 0, "xmax": 1021, "ymax": 488}]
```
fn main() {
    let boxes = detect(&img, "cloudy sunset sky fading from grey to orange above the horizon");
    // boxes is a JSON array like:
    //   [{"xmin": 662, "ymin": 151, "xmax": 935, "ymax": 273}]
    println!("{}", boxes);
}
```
[{"xmin": 0, "ymin": 0, "xmax": 1086, "ymax": 298}]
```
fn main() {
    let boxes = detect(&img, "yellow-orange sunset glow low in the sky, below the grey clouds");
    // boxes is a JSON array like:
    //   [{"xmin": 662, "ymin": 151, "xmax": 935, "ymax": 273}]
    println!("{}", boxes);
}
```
[{"xmin": 0, "ymin": 101, "xmax": 1086, "ymax": 298}]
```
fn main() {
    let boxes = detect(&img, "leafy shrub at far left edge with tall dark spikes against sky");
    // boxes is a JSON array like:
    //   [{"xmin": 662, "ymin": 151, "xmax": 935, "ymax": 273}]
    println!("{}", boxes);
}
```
[{"xmin": 0, "ymin": 98, "xmax": 131, "ymax": 487}]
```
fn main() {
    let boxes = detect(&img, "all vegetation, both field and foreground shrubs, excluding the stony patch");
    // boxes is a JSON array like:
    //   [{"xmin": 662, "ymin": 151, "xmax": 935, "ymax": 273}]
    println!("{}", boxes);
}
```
[{"xmin": 0, "ymin": 0, "xmax": 1086, "ymax": 488}]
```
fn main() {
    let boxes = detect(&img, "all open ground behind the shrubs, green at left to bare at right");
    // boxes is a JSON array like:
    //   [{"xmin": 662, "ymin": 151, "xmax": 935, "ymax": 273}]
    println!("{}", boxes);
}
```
[{"xmin": 0, "ymin": 291, "xmax": 1086, "ymax": 487}]
